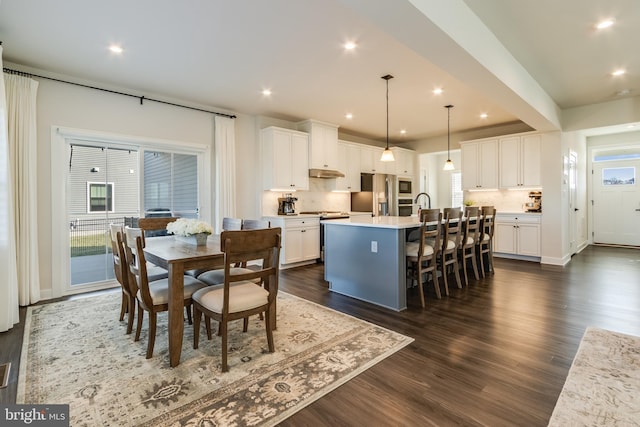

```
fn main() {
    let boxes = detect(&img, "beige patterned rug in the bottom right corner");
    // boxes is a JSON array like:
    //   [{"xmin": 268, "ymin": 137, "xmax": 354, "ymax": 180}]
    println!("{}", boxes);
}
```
[{"xmin": 549, "ymin": 328, "xmax": 640, "ymax": 427}]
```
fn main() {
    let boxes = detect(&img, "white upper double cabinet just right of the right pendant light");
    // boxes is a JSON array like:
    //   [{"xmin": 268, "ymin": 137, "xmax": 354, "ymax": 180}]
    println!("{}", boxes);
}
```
[{"xmin": 460, "ymin": 139, "xmax": 498, "ymax": 190}]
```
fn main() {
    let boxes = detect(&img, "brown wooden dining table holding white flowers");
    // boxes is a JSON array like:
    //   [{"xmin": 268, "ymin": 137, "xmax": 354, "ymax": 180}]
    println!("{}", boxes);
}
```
[{"xmin": 144, "ymin": 234, "xmax": 224, "ymax": 367}]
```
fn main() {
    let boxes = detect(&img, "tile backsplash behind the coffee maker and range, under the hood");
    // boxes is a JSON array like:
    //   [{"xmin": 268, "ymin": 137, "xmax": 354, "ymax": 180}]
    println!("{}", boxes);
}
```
[{"xmin": 262, "ymin": 178, "xmax": 351, "ymax": 216}]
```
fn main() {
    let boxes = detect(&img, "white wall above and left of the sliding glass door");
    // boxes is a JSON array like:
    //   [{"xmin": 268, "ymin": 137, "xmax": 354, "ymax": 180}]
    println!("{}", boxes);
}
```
[{"xmin": 33, "ymin": 79, "xmax": 238, "ymax": 298}]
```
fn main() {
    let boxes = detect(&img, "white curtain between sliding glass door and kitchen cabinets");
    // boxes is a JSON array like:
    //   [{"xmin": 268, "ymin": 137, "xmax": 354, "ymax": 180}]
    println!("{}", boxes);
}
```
[{"xmin": 214, "ymin": 116, "xmax": 236, "ymax": 233}]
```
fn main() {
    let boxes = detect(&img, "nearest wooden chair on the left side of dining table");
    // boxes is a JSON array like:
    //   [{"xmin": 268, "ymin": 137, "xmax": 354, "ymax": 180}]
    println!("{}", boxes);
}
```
[{"xmin": 125, "ymin": 227, "xmax": 207, "ymax": 359}]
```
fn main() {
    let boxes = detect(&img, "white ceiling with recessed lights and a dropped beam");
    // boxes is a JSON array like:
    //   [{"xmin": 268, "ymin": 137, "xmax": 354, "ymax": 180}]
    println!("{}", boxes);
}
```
[{"xmin": 0, "ymin": 0, "xmax": 640, "ymax": 144}]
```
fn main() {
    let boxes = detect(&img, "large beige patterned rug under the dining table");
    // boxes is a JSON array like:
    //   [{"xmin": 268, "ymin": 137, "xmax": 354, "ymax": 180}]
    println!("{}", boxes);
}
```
[{"xmin": 17, "ymin": 292, "xmax": 413, "ymax": 427}]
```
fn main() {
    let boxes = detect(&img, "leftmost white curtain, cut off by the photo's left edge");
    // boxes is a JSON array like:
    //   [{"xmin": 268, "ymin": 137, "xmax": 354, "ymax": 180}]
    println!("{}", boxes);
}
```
[{"xmin": 0, "ymin": 46, "xmax": 20, "ymax": 332}]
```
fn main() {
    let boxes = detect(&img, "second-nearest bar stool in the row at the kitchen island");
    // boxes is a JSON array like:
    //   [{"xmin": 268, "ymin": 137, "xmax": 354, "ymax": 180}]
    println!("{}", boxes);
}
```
[{"xmin": 438, "ymin": 208, "xmax": 462, "ymax": 295}]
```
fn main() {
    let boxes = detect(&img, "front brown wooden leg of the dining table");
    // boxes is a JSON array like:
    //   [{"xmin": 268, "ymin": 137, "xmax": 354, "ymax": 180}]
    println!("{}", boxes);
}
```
[{"xmin": 169, "ymin": 264, "xmax": 184, "ymax": 368}]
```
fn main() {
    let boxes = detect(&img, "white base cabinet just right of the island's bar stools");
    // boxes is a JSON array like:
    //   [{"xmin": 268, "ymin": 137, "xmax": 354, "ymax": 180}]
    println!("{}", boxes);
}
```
[{"xmin": 493, "ymin": 214, "xmax": 540, "ymax": 257}]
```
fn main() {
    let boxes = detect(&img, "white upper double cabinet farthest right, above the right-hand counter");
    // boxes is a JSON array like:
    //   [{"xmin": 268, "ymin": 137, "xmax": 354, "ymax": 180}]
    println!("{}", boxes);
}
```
[{"xmin": 499, "ymin": 134, "xmax": 542, "ymax": 188}]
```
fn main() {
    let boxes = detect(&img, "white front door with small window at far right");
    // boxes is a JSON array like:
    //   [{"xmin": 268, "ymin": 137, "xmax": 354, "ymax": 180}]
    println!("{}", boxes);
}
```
[{"xmin": 592, "ymin": 159, "xmax": 640, "ymax": 246}]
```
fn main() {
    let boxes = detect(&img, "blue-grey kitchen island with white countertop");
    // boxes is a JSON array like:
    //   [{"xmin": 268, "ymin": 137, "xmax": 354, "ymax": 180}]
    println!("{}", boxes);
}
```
[{"xmin": 323, "ymin": 216, "xmax": 420, "ymax": 311}]
